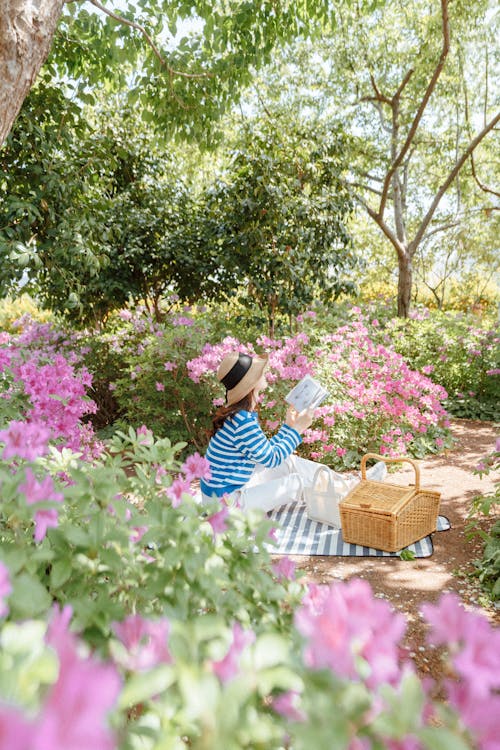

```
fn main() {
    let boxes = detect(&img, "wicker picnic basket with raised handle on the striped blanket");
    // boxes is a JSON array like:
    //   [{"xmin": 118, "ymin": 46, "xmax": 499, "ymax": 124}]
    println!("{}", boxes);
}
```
[{"xmin": 339, "ymin": 453, "xmax": 440, "ymax": 552}]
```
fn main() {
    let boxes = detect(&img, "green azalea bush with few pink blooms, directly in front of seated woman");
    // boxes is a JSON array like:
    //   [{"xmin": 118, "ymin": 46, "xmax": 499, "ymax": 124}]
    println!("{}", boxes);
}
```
[{"xmin": 0, "ymin": 422, "xmax": 296, "ymax": 646}]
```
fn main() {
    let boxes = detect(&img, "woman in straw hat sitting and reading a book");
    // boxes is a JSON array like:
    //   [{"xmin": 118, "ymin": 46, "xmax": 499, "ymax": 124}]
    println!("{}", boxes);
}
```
[{"xmin": 201, "ymin": 352, "xmax": 382, "ymax": 511}]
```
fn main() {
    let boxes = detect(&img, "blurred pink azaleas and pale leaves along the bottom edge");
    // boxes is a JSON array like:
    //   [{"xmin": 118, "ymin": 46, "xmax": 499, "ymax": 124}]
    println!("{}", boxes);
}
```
[{"xmin": 0, "ymin": 563, "xmax": 500, "ymax": 750}]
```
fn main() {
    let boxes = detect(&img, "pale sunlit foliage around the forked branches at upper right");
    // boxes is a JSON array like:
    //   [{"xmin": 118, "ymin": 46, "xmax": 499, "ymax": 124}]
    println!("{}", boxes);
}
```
[{"xmin": 240, "ymin": 0, "xmax": 498, "ymax": 315}]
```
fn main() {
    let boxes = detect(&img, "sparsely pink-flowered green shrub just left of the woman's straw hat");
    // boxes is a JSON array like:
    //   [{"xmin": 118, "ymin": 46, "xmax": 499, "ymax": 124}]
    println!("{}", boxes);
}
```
[{"xmin": 80, "ymin": 308, "xmax": 215, "ymax": 450}]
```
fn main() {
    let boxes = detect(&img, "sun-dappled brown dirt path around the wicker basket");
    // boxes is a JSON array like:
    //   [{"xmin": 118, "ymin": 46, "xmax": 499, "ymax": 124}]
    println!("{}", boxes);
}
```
[{"xmin": 292, "ymin": 420, "xmax": 500, "ymax": 678}]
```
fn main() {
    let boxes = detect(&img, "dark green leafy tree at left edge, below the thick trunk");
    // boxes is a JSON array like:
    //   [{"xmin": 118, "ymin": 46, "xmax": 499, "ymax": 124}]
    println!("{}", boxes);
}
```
[{"xmin": 0, "ymin": 83, "xmax": 210, "ymax": 323}]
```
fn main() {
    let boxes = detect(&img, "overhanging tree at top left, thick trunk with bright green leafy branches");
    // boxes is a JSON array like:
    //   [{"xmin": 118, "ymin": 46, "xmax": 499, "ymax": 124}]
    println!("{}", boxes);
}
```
[{"xmin": 0, "ymin": 0, "xmax": 334, "ymax": 145}]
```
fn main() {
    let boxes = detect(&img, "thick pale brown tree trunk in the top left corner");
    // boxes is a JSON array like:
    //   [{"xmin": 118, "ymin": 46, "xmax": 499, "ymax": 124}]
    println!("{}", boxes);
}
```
[{"xmin": 0, "ymin": 0, "xmax": 65, "ymax": 146}]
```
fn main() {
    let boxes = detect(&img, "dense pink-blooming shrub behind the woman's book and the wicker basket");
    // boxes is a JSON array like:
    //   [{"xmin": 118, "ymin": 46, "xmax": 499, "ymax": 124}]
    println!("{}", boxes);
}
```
[{"xmin": 187, "ymin": 323, "xmax": 449, "ymax": 468}]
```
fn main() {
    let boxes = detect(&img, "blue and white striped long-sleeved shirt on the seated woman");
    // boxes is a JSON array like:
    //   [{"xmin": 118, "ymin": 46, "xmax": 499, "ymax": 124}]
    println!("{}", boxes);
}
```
[{"xmin": 201, "ymin": 410, "xmax": 302, "ymax": 497}]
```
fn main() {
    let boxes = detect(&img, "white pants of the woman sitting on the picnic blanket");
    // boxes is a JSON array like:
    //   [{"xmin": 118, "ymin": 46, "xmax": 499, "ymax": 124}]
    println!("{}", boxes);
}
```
[{"xmin": 200, "ymin": 453, "xmax": 386, "ymax": 513}]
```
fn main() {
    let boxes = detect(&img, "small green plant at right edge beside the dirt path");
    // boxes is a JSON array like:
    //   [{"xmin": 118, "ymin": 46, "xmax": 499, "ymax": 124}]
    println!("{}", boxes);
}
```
[{"xmin": 468, "ymin": 438, "xmax": 500, "ymax": 601}]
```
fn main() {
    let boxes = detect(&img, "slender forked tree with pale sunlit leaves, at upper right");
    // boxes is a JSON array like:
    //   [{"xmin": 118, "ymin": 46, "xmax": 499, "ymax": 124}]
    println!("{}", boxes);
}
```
[{"xmin": 244, "ymin": 0, "xmax": 500, "ymax": 316}]
